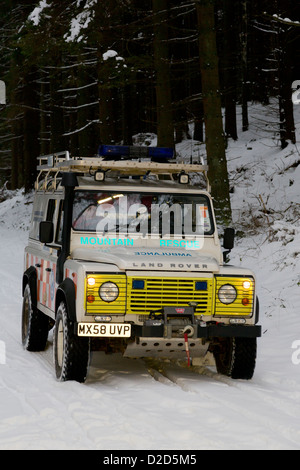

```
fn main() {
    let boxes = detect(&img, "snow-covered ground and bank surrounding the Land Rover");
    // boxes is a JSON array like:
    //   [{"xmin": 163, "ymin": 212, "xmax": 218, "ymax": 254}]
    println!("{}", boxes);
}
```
[{"xmin": 0, "ymin": 106, "xmax": 300, "ymax": 451}]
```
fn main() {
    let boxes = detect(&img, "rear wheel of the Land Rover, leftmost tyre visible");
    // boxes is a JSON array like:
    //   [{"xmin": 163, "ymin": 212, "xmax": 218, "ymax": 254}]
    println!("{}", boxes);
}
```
[{"xmin": 22, "ymin": 284, "xmax": 49, "ymax": 351}]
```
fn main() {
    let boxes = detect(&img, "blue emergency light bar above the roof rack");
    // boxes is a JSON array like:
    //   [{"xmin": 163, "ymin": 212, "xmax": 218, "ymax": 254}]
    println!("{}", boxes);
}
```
[{"xmin": 98, "ymin": 145, "xmax": 174, "ymax": 162}]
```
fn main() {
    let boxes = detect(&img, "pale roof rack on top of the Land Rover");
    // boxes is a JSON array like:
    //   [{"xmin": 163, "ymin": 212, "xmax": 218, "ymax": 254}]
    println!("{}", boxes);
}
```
[{"xmin": 35, "ymin": 147, "xmax": 210, "ymax": 191}]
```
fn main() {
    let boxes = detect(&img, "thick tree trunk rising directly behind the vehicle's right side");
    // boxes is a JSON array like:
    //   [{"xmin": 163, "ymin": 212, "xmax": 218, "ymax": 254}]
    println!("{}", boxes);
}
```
[{"xmin": 196, "ymin": 0, "xmax": 231, "ymax": 225}]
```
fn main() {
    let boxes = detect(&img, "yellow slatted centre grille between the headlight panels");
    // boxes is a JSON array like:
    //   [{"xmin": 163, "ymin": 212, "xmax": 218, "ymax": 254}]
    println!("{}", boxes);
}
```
[{"xmin": 127, "ymin": 277, "xmax": 213, "ymax": 315}]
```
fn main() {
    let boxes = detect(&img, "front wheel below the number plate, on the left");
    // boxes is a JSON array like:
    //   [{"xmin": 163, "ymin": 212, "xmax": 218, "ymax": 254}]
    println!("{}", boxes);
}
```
[{"xmin": 53, "ymin": 302, "xmax": 90, "ymax": 382}]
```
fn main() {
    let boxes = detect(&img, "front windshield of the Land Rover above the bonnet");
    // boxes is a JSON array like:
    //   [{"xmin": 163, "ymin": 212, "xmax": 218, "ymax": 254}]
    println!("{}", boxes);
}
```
[{"xmin": 72, "ymin": 191, "xmax": 214, "ymax": 238}]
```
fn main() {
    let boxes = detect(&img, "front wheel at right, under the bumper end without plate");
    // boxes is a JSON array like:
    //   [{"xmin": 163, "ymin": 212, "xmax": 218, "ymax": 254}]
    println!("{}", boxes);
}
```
[{"xmin": 214, "ymin": 338, "xmax": 257, "ymax": 380}]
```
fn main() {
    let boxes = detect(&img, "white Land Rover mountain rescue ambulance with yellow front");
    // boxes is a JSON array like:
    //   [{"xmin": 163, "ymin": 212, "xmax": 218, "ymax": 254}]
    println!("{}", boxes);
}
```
[{"xmin": 22, "ymin": 146, "xmax": 261, "ymax": 382}]
